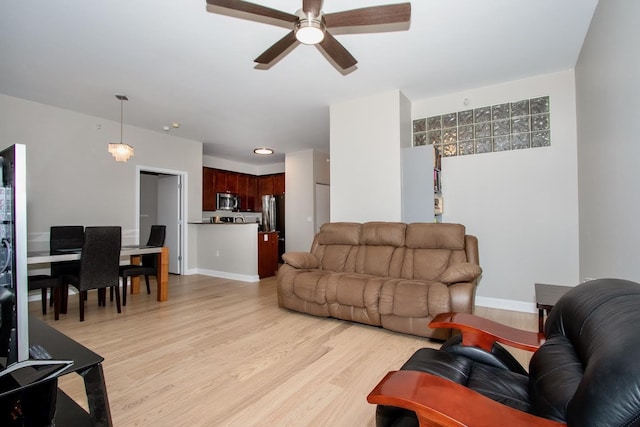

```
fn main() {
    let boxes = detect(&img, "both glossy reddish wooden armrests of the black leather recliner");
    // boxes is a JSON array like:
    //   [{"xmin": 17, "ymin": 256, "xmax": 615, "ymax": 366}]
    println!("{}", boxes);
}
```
[{"xmin": 367, "ymin": 313, "xmax": 566, "ymax": 427}]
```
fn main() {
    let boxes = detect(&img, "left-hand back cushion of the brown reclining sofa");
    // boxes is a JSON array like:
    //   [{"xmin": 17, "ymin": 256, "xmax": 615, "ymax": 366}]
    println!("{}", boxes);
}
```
[{"xmin": 311, "ymin": 222, "xmax": 362, "ymax": 272}]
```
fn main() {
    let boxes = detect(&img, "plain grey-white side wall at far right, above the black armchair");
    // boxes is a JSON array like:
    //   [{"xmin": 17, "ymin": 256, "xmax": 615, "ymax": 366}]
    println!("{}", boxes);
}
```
[{"xmin": 576, "ymin": 1, "xmax": 640, "ymax": 282}]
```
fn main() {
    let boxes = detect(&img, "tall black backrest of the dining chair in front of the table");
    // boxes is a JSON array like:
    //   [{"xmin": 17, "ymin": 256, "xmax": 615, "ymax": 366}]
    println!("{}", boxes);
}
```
[{"xmin": 78, "ymin": 227, "xmax": 122, "ymax": 291}]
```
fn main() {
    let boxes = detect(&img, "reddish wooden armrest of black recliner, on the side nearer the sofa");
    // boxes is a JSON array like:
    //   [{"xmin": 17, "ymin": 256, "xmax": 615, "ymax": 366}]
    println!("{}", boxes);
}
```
[{"xmin": 429, "ymin": 313, "xmax": 545, "ymax": 352}]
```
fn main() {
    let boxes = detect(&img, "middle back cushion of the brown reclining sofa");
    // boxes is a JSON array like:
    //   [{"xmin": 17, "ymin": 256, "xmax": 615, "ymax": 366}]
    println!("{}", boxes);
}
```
[{"xmin": 355, "ymin": 222, "xmax": 407, "ymax": 278}]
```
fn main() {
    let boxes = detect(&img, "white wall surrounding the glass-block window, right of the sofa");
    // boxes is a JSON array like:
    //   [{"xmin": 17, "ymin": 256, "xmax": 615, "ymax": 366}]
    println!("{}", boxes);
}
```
[{"xmin": 412, "ymin": 71, "xmax": 579, "ymax": 311}]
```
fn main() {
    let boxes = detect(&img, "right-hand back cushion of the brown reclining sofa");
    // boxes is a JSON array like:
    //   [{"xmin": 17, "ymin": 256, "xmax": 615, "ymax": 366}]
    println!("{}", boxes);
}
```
[{"xmin": 401, "ymin": 223, "xmax": 467, "ymax": 280}]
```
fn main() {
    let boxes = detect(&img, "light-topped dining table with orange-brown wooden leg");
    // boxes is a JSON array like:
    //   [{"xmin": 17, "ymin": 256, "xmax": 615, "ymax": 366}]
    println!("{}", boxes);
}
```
[{"xmin": 27, "ymin": 245, "xmax": 169, "ymax": 301}]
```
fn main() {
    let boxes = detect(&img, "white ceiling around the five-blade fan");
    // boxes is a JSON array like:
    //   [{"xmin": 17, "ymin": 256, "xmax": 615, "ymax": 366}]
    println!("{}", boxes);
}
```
[{"xmin": 0, "ymin": 0, "xmax": 597, "ymax": 165}]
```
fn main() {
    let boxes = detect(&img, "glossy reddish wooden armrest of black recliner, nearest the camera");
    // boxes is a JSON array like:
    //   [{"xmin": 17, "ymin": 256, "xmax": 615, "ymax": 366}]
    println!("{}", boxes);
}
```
[{"xmin": 367, "ymin": 371, "xmax": 566, "ymax": 427}]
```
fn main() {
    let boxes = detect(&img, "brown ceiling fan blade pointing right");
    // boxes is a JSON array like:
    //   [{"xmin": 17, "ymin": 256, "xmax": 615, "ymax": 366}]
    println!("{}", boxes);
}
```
[{"xmin": 324, "ymin": 3, "xmax": 411, "ymax": 28}]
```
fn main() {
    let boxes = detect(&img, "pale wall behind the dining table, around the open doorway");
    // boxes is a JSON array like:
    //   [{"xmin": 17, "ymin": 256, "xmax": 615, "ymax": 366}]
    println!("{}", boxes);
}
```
[{"xmin": 0, "ymin": 95, "xmax": 202, "ymax": 270}]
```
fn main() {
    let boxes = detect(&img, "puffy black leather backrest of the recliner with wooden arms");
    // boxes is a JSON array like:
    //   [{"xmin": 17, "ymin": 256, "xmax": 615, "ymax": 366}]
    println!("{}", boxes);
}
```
[{"xmin": 529, "ymin": 279, "xmax": 640, "ymax": 426}]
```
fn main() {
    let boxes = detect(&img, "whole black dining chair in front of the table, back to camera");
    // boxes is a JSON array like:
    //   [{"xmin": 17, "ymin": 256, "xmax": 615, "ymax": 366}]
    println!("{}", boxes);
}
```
[{"xmin": 63, "ymin": 227, "xmax": 122, "ymax": 322}]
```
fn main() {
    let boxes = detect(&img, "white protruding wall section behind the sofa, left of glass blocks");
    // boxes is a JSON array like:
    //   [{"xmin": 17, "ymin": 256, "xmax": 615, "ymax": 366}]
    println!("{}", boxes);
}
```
[{"xmin": 330, "ymin": 90, "xmax": 411, "ymax": 222}]
